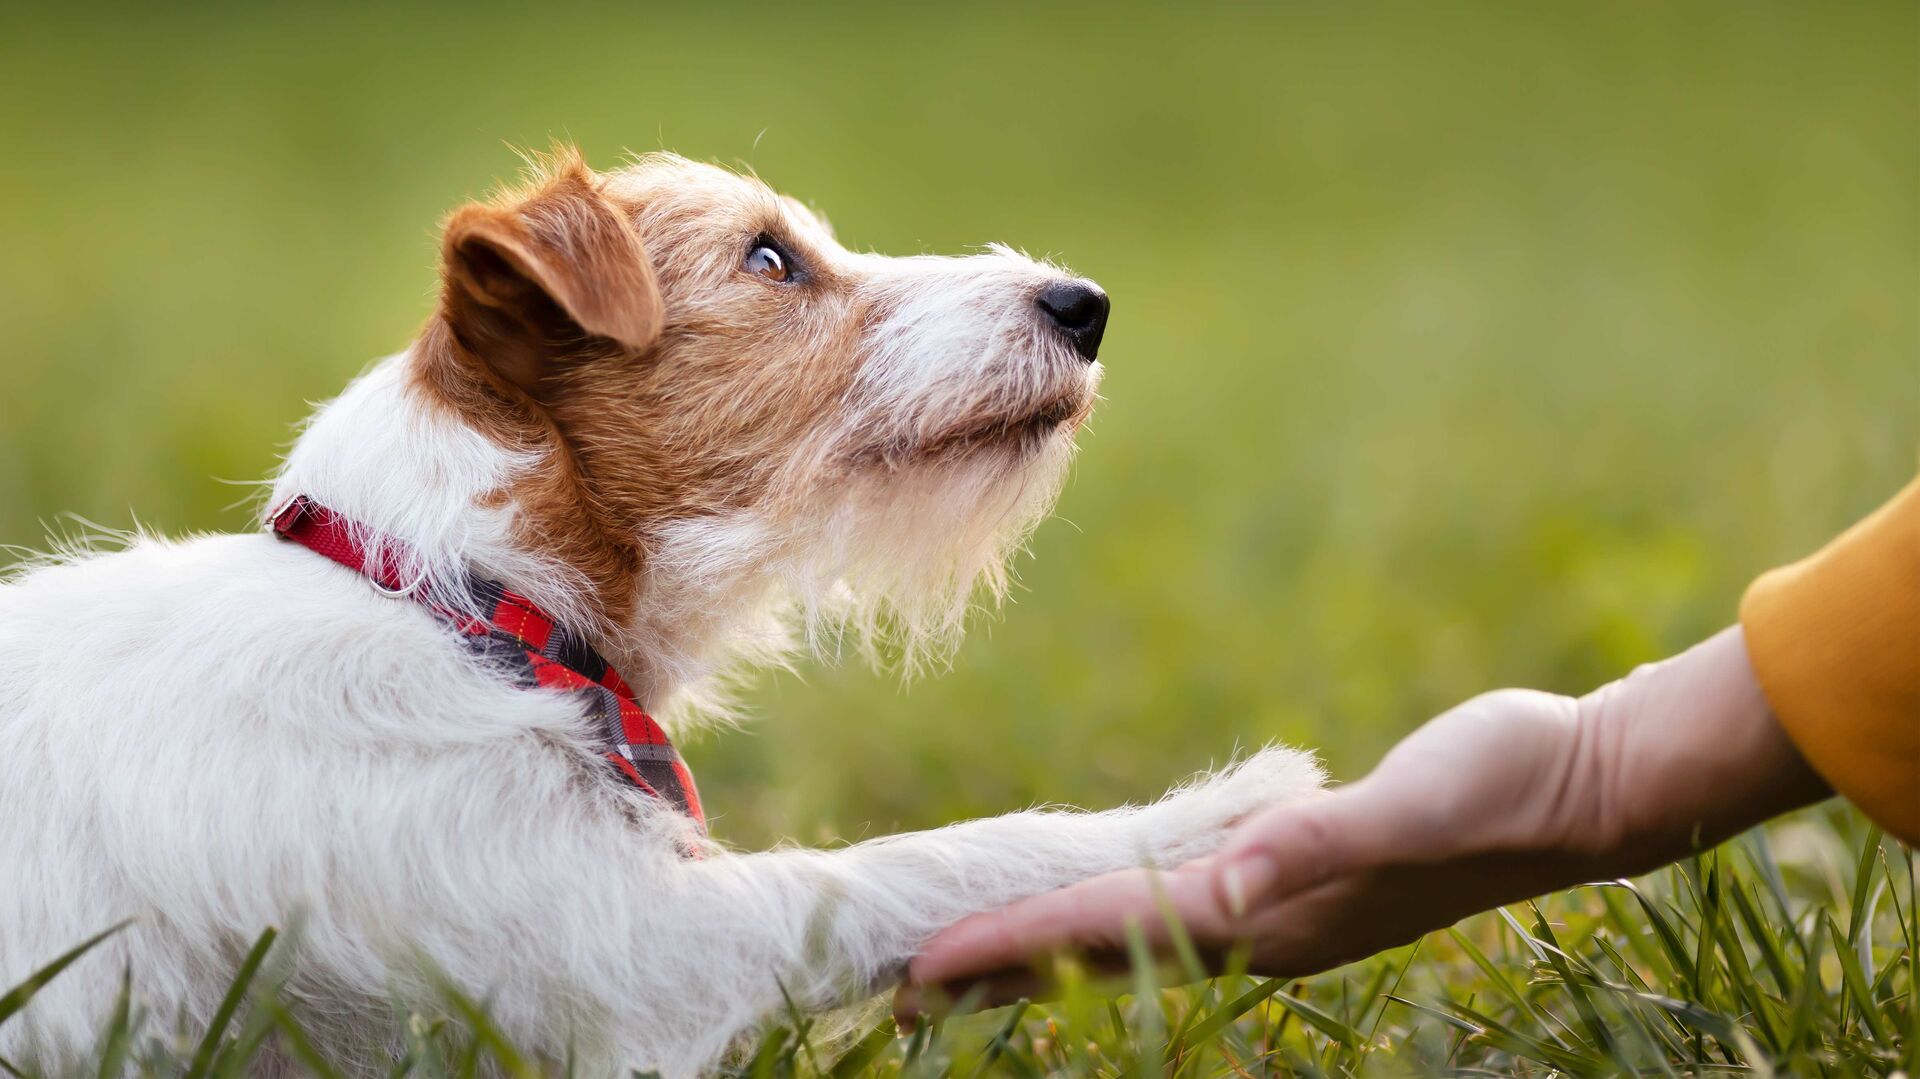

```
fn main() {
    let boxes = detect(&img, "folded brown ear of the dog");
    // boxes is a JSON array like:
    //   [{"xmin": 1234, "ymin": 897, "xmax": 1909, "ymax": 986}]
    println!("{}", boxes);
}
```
[{"xmin": 440, "ymin": 154, "xmax": 660, "ymax": 399}]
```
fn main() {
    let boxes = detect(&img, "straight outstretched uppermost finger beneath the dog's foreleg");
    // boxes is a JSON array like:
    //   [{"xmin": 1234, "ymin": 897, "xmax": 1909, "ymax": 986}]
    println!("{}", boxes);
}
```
[{"xmin": 908, "ymin": 870, "xmax": 1221, "ymax": 985}]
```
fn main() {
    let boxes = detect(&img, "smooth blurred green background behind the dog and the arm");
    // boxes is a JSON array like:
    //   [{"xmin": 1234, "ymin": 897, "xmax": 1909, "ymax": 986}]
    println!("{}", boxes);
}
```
[{"xmin": 0, "ymin": 2, "xmax": 1920, "ymax": 843}]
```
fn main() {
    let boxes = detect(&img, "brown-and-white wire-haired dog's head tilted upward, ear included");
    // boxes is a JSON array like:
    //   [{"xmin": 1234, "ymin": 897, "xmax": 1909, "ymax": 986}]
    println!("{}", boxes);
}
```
[{"xmin": 417, "ymin": 154, "xmax": 1108, "ymax": 679}]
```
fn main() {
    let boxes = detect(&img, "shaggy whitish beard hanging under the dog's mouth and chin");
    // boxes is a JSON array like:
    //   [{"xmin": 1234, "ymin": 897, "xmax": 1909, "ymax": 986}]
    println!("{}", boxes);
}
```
[{"xmin": 630, "ymin": 430, "xmax": 1073, "ymax": 731}]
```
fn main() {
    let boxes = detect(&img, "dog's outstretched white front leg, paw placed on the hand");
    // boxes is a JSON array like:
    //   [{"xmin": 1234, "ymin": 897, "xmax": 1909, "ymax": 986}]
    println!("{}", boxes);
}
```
[{"xmin": 629, "ymin": 749, "xmax": 1321, "ymax": 1067}]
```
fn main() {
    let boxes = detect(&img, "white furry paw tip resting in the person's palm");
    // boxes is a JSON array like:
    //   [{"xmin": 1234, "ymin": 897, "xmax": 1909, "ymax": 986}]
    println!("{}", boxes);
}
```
[{"xmin": 1139, "ymin": 745, "xmax": 1327, "ymax": 866}]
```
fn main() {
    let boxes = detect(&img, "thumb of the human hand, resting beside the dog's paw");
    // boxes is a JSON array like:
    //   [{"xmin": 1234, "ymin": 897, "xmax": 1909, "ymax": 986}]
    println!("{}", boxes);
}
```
[{"xmin": 1210, "ymin": 779, "xmax": 1398, "ymax": 920}]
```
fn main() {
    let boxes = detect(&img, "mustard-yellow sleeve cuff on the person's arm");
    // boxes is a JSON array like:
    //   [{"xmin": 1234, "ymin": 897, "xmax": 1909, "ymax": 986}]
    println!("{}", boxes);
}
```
[{"xmin": 1740, "ymin": 480, "xmax": 1920, "ymax": 845}]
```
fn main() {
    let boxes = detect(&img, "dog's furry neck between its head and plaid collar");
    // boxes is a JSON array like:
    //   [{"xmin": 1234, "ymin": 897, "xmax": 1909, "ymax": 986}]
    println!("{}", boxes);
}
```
[{"xmin": 269, "ymin": 353, "xmax": 789, "ymax": 718}]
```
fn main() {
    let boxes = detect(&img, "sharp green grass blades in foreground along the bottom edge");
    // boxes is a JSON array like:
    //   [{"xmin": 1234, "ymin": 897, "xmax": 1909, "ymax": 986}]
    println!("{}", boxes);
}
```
[{"xmin": 0, "ymin": 814, "xmax": 1920, "ymax": 1079}]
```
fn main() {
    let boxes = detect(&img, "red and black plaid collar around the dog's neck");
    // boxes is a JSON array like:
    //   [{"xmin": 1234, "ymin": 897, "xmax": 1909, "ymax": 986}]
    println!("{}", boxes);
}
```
[{"xmin": 269, "ymin": 495, "xmax": 707, "ymax": 829}]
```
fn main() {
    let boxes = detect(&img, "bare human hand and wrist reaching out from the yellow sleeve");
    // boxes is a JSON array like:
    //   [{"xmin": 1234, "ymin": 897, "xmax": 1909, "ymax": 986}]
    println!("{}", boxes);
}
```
[{"xmin": 895, "ymin": 628, "xmax": 1826, "ymax": 1016}]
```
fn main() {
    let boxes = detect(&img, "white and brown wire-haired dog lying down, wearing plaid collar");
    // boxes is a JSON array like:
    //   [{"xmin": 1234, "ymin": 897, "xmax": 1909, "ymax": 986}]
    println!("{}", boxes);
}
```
[{"xmin": 0, "ymin": 148, "xmax": 1321, "ymax": 1075}]
